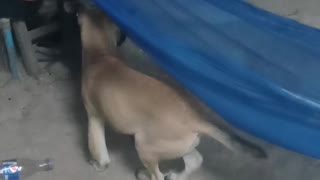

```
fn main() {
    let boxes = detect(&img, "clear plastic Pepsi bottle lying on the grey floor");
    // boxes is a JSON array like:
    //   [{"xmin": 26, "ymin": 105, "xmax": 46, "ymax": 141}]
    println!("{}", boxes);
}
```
[{"xmin": 0, "ymin": 159, "xmax": 53, "ymax": 180}]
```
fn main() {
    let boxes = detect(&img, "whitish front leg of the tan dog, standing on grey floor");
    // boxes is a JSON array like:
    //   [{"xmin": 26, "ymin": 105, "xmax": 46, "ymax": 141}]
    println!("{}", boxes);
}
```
[{"xmin": 88, "ymin": 115, "xmax": 110, "ymax": 171}]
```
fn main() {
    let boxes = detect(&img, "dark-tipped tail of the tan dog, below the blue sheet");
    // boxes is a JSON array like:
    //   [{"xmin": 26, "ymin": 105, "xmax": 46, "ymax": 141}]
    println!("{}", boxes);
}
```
[{"xmin": 198, "ymin": 122, "xmax": 267, "ymax": 159}]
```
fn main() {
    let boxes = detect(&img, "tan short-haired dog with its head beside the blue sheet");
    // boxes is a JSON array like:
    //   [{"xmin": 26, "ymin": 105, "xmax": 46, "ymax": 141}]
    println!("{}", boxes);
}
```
[{"xmin": 79, "ymin": 6, "xmax": 264, "ymax": 180}]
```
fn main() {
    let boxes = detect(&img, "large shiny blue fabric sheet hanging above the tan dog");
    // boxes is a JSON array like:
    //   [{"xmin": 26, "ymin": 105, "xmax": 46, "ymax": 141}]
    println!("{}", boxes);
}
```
[{"xmin": 95, "ymin": 0, "xmax": 320, "ymax": 158}]
